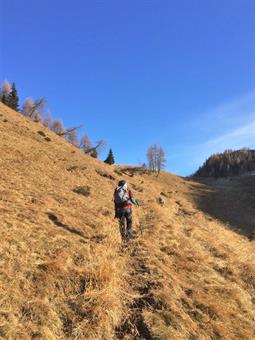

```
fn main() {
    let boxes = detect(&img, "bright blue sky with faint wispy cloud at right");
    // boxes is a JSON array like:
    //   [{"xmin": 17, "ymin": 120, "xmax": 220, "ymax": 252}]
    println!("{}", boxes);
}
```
[{"xmin": 0, "ymin": 0, "xmax": 255, "ymax": 175}]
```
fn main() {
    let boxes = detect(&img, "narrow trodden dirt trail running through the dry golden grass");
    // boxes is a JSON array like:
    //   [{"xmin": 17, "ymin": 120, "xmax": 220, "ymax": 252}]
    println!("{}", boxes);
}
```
[{"xmin": 115, "ymin": 206, "xmax": 162, "ymax": 340}]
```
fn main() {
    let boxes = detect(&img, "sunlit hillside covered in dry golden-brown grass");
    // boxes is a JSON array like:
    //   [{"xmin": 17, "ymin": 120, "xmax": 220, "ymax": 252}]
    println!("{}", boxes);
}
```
[{"xmin": 0, "ymin": 104, "xmax": 255, "ymax": 340}]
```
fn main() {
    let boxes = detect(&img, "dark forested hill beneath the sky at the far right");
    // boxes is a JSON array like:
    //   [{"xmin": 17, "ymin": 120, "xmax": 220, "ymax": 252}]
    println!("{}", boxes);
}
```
[{"xmin": 194, "ymin": 149, "xmax": 255, "ymax": 177}]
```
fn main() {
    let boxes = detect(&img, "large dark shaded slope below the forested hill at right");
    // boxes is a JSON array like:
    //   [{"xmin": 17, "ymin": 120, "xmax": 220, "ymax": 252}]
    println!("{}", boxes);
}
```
[{"xmin": 191, "ymin": 176, "xmax": 255, "ymax": 237}]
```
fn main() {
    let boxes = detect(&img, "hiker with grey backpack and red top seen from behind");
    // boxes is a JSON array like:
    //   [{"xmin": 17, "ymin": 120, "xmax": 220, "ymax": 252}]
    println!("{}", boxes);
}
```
[{"xmin": 114, "ymin": 180, "xmax": 139, "ymax": 241}]
